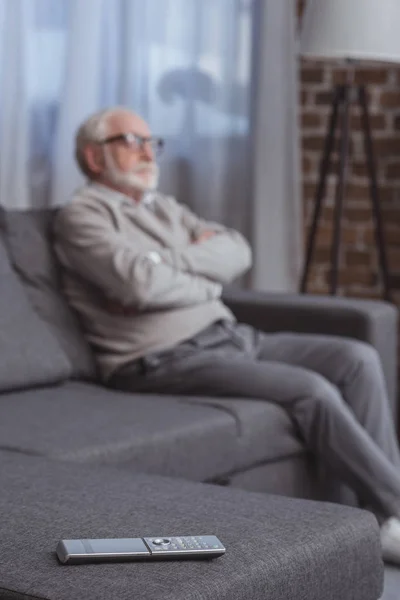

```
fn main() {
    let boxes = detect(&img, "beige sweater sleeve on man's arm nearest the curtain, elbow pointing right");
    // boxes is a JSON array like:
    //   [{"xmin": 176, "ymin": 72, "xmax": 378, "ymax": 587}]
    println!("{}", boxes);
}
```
[{"xmin": 160, "ymin": 199, "xmax": 252, "ymax": 284}]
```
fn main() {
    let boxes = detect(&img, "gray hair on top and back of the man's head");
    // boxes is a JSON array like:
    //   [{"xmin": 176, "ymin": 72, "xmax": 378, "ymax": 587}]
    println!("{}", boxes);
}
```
[{"xmin": 75, "ymin": 106, "xmax": 128, "ymax": 178}]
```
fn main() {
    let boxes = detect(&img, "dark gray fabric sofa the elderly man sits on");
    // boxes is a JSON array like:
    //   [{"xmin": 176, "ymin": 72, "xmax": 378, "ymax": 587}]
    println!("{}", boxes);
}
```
[{"xmin": 0, "ymin": 210, "xmax": 397, "ymax": 600}]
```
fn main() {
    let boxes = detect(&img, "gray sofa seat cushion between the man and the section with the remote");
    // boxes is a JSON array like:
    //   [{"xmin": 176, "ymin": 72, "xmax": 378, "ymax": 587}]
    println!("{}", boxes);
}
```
[{"xmin": 0, "ymin": 382, "xmax": 237, "ymax": 481}]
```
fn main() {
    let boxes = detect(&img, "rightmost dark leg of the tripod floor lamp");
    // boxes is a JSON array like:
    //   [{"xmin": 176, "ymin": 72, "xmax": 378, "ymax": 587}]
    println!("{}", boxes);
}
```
[{"xmin": 359, "ymin": 85, "xmax": 390, "ymax": 301}]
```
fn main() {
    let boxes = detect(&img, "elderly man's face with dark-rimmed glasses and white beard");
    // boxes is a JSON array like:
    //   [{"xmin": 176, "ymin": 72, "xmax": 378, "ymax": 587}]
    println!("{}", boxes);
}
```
[{"xmin": 90, "ymin": 112, "xmax": 158, "ymax": 192}]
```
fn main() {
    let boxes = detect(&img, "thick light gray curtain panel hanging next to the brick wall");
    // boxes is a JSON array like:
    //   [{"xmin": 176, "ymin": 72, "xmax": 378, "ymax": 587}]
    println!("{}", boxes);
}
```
[{"xmin": 252, "ymin": 0, "xmax": 303, "ymax": 292}]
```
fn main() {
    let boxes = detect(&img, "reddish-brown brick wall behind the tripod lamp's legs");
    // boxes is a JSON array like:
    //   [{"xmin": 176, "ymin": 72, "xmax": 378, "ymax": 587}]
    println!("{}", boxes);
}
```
[{"xmin": 297, "ymin": 1, "xmax": 400, "ymax": 305}]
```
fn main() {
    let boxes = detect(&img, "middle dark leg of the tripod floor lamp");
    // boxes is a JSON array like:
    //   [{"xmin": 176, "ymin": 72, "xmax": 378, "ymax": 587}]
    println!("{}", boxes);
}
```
[{"xmin": 330, "ymin": 85, "xmax": 352, "ymax": 295}]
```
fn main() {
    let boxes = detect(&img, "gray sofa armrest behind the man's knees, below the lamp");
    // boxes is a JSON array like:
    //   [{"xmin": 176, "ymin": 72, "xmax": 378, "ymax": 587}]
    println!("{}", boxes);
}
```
[{"xmin": 223, "ymin": 288, "xmax": 398, "ymax": 424}]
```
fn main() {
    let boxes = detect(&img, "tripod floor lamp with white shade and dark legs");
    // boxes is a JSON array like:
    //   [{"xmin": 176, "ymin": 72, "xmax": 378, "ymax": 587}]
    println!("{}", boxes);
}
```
[{"xmin": 300, "ymin": 0, "xmax": 400, "ymax": 300}]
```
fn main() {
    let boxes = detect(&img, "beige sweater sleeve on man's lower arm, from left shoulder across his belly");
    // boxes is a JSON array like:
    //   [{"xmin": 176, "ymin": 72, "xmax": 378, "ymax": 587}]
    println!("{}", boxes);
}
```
[{"xmin": 54, "ymin": 202, "xmax": 222, "ymax": 310}]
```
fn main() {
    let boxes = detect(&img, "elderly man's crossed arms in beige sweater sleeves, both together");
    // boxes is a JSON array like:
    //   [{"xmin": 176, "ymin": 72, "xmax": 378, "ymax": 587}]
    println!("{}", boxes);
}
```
[{"xmin": 55, "ymin": 201, "xmax": 251, "ymax": 310}]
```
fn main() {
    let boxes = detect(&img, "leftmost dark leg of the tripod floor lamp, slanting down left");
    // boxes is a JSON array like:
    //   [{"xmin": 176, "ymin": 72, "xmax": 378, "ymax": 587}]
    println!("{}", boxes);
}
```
[{"xmin": 300, "ymin": 86, "xmax": 343, "ymax": 294}]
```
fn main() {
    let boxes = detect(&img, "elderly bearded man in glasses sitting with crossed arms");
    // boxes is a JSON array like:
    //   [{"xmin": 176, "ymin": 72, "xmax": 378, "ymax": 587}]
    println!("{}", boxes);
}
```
[{"xmin": 55, "ymin": 108, "xmax": 400, "ymax": 563}]
